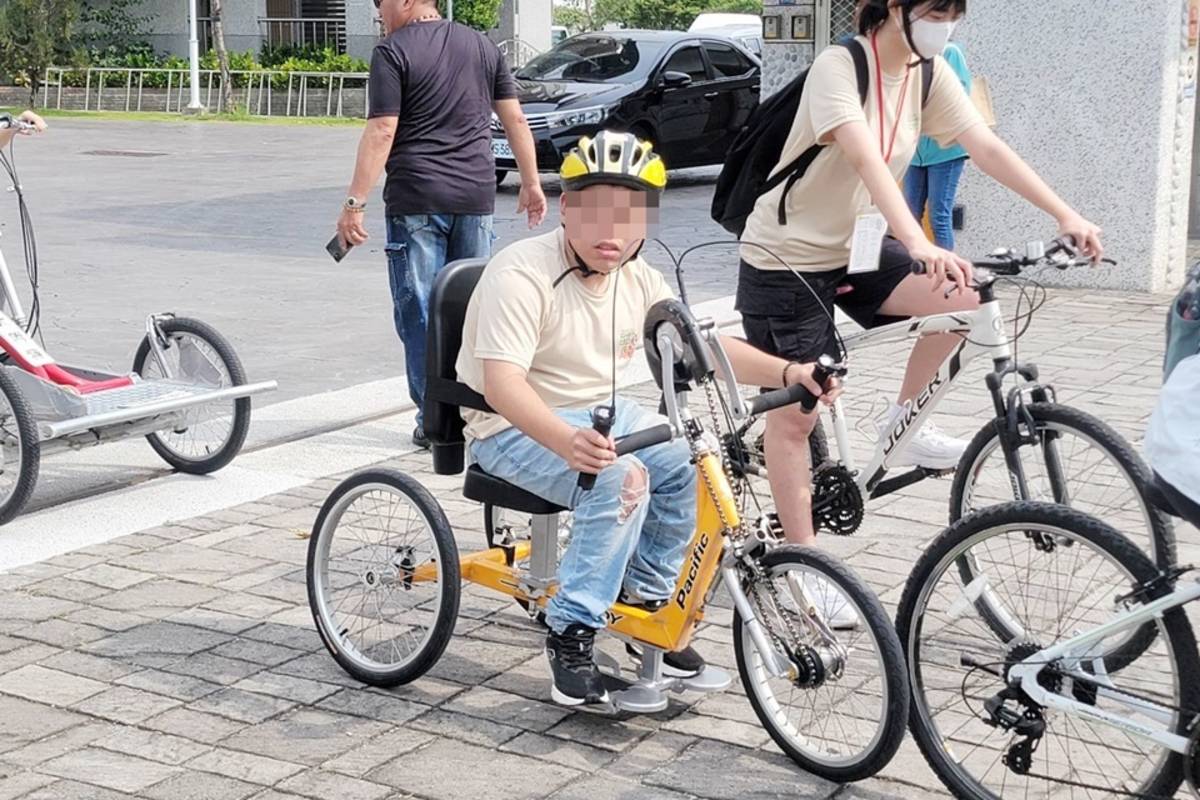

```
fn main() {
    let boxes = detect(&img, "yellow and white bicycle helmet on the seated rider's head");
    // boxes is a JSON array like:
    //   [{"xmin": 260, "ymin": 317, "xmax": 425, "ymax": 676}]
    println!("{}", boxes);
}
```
[{"xmin": 558, "ymin": 131, "xmax": 667, "ymax": 192}]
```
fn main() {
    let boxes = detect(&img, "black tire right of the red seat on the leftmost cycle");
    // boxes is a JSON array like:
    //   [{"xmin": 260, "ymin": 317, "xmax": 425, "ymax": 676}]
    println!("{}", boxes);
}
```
[{"xmin": 133, "ymin": 317, "xmax": 250, "ymax": 475}]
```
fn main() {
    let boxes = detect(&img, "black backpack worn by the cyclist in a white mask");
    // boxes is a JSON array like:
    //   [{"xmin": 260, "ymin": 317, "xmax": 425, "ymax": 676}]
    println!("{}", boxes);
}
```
[{"xmin": 712, "ymin": 38, "xmax": 934, "ymax": 237}]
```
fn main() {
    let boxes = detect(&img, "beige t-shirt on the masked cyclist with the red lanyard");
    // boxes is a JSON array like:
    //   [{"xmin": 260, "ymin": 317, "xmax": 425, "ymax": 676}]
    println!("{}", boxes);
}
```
[{"xmin": 742, "ymin": 36, "xmax": 983, "ymax": 272}]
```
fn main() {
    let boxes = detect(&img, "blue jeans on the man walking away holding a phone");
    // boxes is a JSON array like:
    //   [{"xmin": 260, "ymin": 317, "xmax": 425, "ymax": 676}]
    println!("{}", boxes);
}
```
[{"xmin": 385, "ymin": 213, "xmax": 496, "ymax": 427}]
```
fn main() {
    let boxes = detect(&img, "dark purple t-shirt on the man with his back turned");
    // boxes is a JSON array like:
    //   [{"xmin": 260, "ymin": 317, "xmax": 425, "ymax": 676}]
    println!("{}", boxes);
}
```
[{"xmin": 370, "ymin": 19, "xmax": 516, "ymax": 216}]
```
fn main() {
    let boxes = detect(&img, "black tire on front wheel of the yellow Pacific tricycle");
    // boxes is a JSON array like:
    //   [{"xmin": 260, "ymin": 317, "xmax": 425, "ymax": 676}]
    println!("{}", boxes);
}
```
[{"xmin": 733, "ymin": 545, "xmax": 908, "ymax": 783}]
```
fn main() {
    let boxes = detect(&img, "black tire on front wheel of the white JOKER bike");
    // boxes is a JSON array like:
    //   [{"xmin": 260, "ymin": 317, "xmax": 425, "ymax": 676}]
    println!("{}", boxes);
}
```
[{"xmin": 950, "ymin": 403, "xmax": 1175, "ymax": 670}]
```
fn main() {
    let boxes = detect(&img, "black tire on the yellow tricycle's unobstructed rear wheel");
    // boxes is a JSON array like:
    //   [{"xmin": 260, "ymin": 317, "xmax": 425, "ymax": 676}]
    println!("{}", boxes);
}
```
[{"xmin": 305, "ymin": 469, "xmax": 462, "ymax": 687}]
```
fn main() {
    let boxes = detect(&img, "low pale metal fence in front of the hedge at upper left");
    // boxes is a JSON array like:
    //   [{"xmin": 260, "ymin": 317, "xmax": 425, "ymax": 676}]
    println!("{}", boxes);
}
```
[{"xmin": 46, "ymin": 67, "xmax": 370, "ymax": 118}]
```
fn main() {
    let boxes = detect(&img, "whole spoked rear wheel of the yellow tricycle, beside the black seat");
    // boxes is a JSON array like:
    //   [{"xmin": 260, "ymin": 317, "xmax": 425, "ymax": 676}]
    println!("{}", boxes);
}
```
[{"xmin": 307, "ymin": 469, "xmax": 462, "ymax": 686}]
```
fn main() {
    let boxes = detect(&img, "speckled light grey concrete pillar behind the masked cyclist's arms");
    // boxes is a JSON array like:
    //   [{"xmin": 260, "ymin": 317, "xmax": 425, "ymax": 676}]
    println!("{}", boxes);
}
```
[{"xmin": 958, "ymin": 0, "xmax": 1200, "ymax": 291}]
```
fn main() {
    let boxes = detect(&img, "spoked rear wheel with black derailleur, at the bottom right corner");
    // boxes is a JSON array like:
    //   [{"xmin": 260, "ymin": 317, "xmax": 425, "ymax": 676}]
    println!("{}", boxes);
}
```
[{"xmin": 896, "ymin": 503, "xmax": 1200, "ymax": 799}]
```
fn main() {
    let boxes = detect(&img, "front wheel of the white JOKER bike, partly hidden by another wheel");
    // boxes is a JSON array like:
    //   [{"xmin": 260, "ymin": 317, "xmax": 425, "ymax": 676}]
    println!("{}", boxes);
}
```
[{"xmin": 950, "ymin": 403, "xmax": 1175, "ymax": 669}]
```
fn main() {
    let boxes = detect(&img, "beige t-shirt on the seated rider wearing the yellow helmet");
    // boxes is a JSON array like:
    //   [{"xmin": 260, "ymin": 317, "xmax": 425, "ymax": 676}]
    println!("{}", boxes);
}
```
[{"xmin": 456, "ymin": 228, "xmax": 674, "ymax": 439}]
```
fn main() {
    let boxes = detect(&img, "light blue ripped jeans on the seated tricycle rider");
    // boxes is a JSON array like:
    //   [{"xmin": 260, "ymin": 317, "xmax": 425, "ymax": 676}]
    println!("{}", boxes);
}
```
[{"xmin": 470, "ymin": 398, "xmax": 696, "ymax": 633}]
